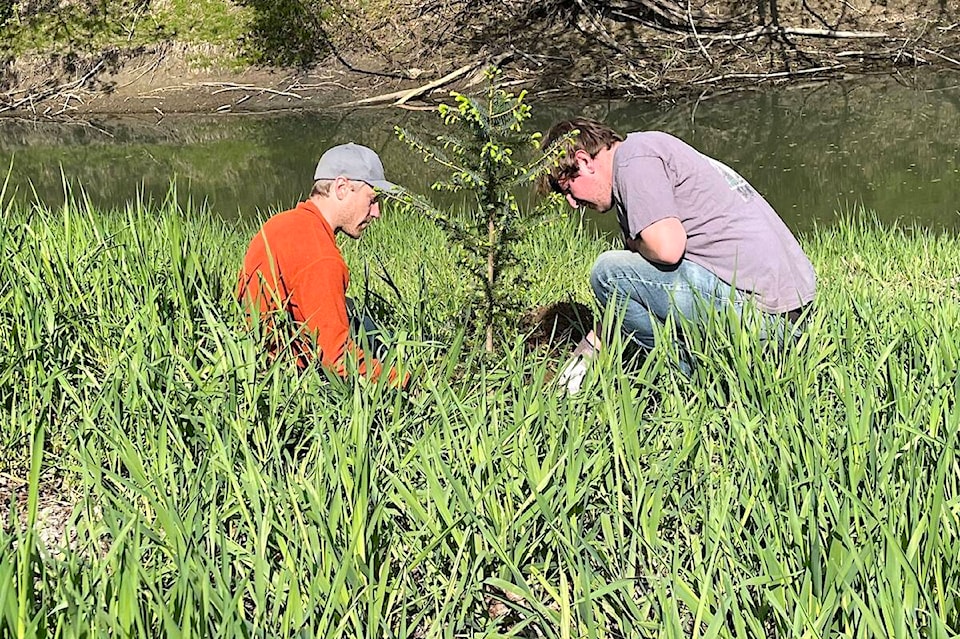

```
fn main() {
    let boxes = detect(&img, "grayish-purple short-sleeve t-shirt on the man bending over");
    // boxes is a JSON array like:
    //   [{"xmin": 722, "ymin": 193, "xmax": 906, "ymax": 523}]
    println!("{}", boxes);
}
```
[{"xmin": 613, "ymin": 131, "xmax": 816, "ymax": 313}]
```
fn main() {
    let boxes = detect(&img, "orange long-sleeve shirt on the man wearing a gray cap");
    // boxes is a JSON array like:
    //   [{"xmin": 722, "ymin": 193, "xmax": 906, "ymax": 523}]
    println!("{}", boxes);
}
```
[{"xmin": 237, "ymin": 201, "xmax": 380, "ymax": 376}]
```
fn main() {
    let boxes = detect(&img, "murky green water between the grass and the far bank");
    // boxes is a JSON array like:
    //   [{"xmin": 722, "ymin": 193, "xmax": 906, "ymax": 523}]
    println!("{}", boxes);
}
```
[{"xmin": 0, "ymin": 71, "xmax": 960, "ymax": 233}]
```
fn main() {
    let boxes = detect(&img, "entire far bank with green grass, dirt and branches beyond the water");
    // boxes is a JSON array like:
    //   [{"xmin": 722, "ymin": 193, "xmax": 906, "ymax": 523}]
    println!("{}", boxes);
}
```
[{"xmin": 0, "ymin": 0, "xmax": 960, "ymax": 117}]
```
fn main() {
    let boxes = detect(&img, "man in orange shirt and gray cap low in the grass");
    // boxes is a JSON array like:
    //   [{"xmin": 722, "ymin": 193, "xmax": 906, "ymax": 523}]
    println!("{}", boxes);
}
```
[{"xmin": 237, "ymin": 143, "xmax": 397, "ymax": 379}]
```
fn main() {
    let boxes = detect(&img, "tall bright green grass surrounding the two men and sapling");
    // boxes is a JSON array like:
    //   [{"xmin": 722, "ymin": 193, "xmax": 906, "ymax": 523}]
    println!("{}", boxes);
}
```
[{"xmin": 0, "ymin": 185, "xmax": 960, "ymax": 637}]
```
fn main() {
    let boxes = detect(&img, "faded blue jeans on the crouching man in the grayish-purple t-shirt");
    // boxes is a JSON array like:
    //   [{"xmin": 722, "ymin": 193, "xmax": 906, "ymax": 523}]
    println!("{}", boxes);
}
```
[{"xmin": 590, "ymin": 251, "xmax": 746, "ymax": 375}]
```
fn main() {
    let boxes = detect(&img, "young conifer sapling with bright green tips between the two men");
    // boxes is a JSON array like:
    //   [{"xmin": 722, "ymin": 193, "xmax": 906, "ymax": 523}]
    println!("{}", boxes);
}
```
[{"xmin": 396, "ymin": 69, "xmax": 557, "ymax": 352}]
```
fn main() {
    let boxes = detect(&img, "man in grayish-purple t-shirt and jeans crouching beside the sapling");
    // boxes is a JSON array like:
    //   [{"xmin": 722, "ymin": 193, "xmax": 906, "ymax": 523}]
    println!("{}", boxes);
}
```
[{"xmin": 542, "ymin": 119, "xmax": 816, "ymax": 392}]
